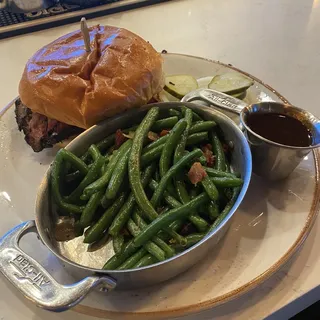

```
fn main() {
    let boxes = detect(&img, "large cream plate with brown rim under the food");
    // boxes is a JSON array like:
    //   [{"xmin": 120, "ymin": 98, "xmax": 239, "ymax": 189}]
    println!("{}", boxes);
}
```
[{"xmin": 0, "ymin": 54, "xmax": 320, "ymax": 320}]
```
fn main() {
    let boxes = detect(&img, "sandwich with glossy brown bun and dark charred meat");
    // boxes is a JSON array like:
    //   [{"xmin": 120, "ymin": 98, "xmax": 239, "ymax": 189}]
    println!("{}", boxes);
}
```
[{"xmin": 15, "ymin": 25, "xmax": 164, "ymax": 152}]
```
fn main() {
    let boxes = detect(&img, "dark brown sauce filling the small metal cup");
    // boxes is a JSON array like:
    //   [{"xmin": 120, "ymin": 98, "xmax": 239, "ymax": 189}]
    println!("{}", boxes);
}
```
[{"xmin": 246, "ymin": 112, "xmax": 312, "ymax": 147}]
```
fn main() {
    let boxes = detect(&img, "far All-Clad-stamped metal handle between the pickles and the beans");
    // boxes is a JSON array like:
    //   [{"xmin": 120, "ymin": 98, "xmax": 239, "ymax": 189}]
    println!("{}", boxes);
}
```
[{"xmin": 181, "ymin": 89, "xmax": 248, "ymax": 114}]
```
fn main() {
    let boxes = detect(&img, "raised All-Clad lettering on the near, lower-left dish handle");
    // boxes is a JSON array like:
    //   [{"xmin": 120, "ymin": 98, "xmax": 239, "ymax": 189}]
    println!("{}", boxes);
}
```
[{"xmin": 10, "ymin": 254, "xmax": 50, "ymax": 290}]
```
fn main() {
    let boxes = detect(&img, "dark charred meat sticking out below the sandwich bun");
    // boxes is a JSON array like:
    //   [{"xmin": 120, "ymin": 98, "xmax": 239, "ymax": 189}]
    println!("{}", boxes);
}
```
[{"xmin": 15, "ymin": 99, "xmax": 83, "ymax": 152}]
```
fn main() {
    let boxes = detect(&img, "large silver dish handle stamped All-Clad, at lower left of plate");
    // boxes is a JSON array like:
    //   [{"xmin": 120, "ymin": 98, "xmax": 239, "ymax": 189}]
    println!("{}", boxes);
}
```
[{"xmin": 0, "ymin": 220, "xmax": 116, "ymax": 312}]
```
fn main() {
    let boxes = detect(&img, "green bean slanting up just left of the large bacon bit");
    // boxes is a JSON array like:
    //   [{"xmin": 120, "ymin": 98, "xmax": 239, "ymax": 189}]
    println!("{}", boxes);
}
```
[{"xmin": 151, "ymin": 149, "xmax": 202, "ymax": 209}]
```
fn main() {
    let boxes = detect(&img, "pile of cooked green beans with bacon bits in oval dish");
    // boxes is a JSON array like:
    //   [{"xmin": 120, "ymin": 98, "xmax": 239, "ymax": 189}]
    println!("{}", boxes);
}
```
[{"xmin": 50, "ymin": 107, "xmax": 243, "ymax": 270}]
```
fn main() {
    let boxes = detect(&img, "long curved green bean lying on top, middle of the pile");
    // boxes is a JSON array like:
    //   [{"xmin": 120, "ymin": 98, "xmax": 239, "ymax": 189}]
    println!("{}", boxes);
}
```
[{"xmin": 128, "ymin": 107, "xmax": 159, "ymax": 220}]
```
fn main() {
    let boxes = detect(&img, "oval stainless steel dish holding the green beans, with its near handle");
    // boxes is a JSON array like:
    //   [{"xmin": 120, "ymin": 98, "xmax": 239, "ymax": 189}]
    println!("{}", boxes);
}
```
[{"xmin": 0, "ymin": 102, "xmax": 252, "ymax": 311}]
